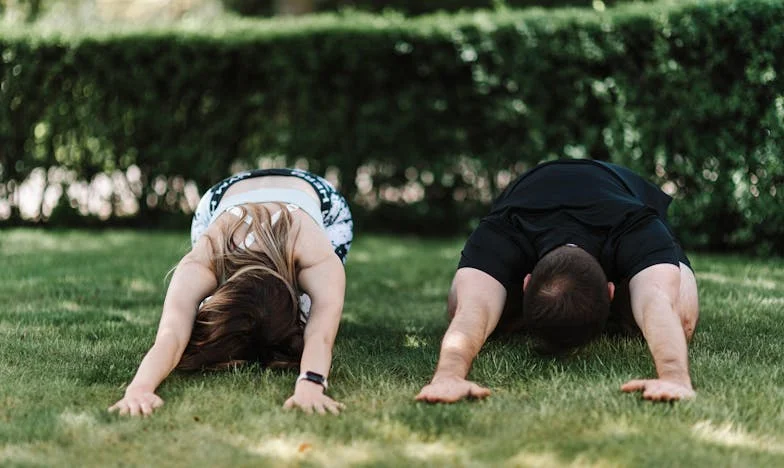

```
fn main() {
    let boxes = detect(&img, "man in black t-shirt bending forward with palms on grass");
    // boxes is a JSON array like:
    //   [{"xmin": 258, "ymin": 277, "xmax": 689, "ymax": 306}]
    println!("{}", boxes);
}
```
[{"xmin": 416, "ymin": 160, "xmax": 699, "ymax": 403}]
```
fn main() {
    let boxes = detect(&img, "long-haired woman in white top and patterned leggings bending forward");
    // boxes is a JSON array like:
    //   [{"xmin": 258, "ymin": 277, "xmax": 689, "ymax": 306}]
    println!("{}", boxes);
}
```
[{"xmin": 109, "ymin": 169, "xmax": 353, "ymax": 416}]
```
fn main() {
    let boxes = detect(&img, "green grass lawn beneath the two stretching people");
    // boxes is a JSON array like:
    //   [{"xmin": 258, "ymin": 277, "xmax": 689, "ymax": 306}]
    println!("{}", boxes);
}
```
[{"xmin": 0, "ymin": 230, "xmax": 784, "ymax": 467}]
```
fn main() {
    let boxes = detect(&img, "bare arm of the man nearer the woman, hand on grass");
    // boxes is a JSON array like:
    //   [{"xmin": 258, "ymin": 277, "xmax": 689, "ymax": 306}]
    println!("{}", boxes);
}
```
[{"xmin": 416, "ymin": 268, "xmax": 506, "ymax": 403}]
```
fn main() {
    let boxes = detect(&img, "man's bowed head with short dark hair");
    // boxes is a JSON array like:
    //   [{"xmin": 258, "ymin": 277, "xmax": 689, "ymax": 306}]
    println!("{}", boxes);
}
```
[{"xmin": 523, "ymin": 244, "xmax": 615, "ymax": 353}]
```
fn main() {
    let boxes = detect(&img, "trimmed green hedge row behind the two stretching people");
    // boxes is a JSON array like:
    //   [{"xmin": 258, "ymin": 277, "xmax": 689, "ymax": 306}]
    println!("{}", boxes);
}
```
[{"xmin": 0, "ymin": 0, "xmax": 784, "ymax": 253}]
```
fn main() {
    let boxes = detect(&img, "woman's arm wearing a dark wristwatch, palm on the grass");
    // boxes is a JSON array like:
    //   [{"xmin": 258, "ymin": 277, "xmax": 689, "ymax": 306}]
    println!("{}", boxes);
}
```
[{"xmin": 284, "ymin": 221, "xmax": 346, "ymax": 414}]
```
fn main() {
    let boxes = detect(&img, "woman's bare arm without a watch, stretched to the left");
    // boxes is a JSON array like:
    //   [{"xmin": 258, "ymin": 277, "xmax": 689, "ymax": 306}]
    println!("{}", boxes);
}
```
[{"xmin": 109, "ymin": 238, "xmax": 217, "ymax": 416}]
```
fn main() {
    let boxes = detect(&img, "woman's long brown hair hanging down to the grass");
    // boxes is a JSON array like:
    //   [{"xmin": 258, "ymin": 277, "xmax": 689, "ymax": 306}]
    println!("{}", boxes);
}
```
[{"xmin": 177, "ymin": 204, "xmax": 303, "ymax": 370}]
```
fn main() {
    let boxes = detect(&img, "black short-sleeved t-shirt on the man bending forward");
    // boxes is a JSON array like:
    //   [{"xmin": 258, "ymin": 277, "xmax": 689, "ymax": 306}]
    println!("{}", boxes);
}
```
[{"xmin": 458, "ymin": 160, "xmax": 689, "ymax": 308}]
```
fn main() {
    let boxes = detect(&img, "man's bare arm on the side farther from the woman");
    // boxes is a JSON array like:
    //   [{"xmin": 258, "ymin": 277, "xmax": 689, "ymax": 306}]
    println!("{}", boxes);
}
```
[{"xmin": 621, "ymin": 264, "xmax": 695, "ymax": 401}]
